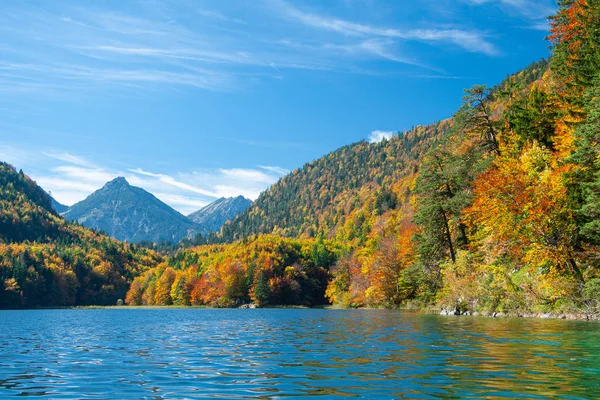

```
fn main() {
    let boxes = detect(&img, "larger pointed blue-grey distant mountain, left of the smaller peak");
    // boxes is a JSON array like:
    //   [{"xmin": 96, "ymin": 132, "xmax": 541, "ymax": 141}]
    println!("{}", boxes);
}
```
[{"xmin": 63, "ymin": 178, "xmax": 200, "ymax": 243}]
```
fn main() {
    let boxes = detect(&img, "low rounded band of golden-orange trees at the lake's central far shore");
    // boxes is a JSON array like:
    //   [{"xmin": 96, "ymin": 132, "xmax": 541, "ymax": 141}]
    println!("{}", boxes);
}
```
[{"xmin": 127, "ymin": 235, "xmax": 335, "ymax": 307}]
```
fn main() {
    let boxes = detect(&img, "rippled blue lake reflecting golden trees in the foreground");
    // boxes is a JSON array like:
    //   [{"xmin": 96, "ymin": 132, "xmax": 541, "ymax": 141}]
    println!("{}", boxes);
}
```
[{"xmin": 0, "ymin": 308, "xmax": 600, "ymax": 399}]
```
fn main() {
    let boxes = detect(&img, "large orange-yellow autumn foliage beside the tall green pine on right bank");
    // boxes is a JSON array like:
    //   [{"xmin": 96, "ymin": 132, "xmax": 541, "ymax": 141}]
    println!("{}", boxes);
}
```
[{"xmin": 465, "ymin": 142, "xmax": 583, "ymax": 300}]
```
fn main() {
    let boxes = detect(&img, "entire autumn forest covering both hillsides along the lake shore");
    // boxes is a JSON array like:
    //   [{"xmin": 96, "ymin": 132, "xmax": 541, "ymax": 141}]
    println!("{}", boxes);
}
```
[{"xmin": 0, "ymin": 0, "xmax": 600, "ymax": 316}]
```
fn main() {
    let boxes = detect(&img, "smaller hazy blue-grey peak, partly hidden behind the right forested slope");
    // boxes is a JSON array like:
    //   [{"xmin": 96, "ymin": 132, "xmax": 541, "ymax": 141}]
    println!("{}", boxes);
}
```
[{"xmin": 188, "ymin": 196, "xmax": 252, "ymax": 234}]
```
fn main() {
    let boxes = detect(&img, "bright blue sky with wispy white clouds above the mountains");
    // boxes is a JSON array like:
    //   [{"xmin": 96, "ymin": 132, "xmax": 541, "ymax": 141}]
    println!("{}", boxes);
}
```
[{"xmin": 0, "ymin": 0, "xmax": 555, "ymax": 214}]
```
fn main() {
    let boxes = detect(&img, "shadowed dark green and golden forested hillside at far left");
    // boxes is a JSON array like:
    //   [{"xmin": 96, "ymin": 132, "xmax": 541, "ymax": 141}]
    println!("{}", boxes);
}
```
[{"xmin": 0, "ymin": 163, "xmax": 161, "ymax": 308}]
